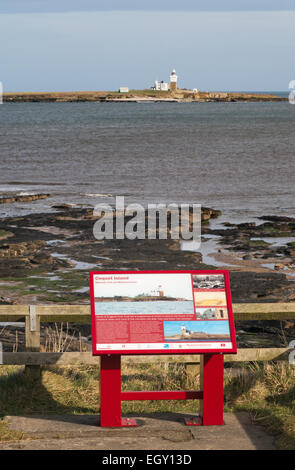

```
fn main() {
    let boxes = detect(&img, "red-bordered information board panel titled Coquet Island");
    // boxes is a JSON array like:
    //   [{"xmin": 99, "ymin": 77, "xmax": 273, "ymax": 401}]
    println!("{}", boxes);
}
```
[{"xmin": 90, "ymin": 270, "xmax": 237, "ymax": 355}]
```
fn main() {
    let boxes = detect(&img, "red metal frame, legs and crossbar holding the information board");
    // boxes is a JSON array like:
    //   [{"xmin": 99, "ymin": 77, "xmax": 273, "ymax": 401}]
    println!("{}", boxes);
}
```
[{"xmin": 90, "ymin": 270, "xmax": 237, "ymax": 427}]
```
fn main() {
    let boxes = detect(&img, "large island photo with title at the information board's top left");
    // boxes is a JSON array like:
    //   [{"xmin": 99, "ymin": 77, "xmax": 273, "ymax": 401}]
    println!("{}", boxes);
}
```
[{"xmin": 94, "ymin": 273, "xmax": 194, "ymax": 315}]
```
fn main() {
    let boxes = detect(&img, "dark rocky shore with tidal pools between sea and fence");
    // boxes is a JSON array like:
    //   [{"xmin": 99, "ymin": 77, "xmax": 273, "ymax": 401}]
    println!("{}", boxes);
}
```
[{"xmin": 0, "ymin": 200, "xmax": 295, "ymax": 350}]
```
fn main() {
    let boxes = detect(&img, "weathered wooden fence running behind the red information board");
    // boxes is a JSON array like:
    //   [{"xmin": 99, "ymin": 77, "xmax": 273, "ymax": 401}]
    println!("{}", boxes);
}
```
[{"xmin": 0, "ymin": 303, "xmax": 295, "ymax": 367}]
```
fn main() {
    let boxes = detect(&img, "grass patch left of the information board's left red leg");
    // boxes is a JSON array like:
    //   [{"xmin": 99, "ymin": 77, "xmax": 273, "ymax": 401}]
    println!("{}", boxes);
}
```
[{"xmin": 0, "ymin": 366, "xmax": 98, "ymax": 417}]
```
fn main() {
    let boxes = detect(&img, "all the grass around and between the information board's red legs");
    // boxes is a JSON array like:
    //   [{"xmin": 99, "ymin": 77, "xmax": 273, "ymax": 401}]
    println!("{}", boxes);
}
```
[{"xmin": 0, "ymin": 363, "xmax": 295, "ymax": 449}]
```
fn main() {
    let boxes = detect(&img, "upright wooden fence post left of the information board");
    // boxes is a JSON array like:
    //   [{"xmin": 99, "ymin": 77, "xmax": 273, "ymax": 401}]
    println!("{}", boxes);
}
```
[{"xmin": 25, "ymin": 305, "xmax": 41, "ymax": 378}]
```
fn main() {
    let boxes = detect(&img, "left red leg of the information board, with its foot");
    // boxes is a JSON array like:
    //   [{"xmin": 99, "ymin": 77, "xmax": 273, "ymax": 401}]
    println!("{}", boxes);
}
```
[{"xmin": 100, "ymin": 354, "xmax": 136, "ymax": 427}]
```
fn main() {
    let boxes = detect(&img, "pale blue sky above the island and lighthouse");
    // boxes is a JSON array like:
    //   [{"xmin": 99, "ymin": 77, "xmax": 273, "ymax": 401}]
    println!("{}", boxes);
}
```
[{"xmin": 0, "ymin": 0, "xmax": 295, "ymax": 92}]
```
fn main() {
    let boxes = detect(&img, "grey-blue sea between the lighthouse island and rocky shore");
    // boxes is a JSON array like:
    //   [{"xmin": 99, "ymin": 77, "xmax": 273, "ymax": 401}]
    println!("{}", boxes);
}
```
[{"xmin": 0, "ymin": 96, "xmax": 295, "ymax": 222}]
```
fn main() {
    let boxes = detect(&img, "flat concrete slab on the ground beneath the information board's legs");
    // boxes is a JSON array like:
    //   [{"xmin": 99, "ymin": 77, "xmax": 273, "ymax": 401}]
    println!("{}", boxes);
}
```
[{"xmin": 0, "ymin": 413, "xmax": 275, "ymax": 450}]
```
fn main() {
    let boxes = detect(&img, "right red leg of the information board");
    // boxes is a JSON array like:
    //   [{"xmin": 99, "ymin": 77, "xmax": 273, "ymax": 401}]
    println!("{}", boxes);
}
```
[{"xmin": 201, "ymin": 354, "xmax": 224, "ymax": 426}]
